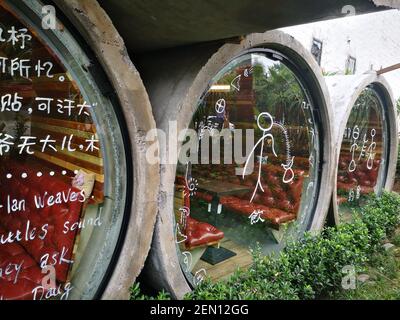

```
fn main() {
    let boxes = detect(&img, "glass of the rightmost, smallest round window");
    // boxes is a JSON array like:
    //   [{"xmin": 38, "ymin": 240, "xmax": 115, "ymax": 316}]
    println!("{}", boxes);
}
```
[{"xmin": 337, "ymin": 85, "xmax": 388, "ymax": 221}]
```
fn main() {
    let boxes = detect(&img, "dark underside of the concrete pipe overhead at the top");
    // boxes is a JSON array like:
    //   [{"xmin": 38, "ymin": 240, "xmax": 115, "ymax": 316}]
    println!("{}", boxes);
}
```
[{"xmin": 99, "ymin": 0, "xmax": 385, "ymax": 53}]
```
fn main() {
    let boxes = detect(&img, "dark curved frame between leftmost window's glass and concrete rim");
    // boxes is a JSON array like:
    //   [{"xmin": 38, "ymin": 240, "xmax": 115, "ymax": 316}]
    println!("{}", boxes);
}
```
[{"xmin": 4, "ymin": 0, "xmax": 134, "ymax": 300}]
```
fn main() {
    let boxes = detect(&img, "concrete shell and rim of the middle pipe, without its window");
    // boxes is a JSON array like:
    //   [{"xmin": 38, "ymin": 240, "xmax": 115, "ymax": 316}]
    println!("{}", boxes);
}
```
[{"xmin": 135, "ymin": 31, "xmax": 335, "ymax": 298}]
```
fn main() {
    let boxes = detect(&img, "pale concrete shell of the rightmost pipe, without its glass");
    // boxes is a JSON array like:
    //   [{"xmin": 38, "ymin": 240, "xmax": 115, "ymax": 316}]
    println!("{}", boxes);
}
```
[{"xmin": 325, "ymin": 72, "xmax": 398, "ymax": 224}]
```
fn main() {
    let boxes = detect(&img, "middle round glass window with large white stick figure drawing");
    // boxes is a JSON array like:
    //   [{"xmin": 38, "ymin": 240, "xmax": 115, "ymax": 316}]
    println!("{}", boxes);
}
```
[{"xmin": 174, "ymin": 49, "xmax": 321, "ymax": 285}]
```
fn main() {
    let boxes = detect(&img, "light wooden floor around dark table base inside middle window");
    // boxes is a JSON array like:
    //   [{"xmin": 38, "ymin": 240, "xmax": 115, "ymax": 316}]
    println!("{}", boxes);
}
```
[{"xmin": 196, "ymin": 238, "xmax": 252, "ymax": 281}]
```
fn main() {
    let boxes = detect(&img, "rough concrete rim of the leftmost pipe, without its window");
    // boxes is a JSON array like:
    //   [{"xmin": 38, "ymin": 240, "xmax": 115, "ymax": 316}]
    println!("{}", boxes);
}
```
[{"xmin": 55, "ymin": 0, "xmax": 159, "ymax": 299}]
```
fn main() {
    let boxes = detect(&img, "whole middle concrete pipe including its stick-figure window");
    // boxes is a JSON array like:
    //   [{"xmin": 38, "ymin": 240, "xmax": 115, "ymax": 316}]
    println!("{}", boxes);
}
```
[{"xmin": 138, "ymin": 32, "xmax": 334, "ymax": 298}]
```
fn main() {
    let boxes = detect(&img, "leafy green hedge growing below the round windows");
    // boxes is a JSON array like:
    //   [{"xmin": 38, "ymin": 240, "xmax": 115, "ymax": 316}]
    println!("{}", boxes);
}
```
[{"xmin": 131, "ymin": 193, "xmax": 400, "ymax": 300}]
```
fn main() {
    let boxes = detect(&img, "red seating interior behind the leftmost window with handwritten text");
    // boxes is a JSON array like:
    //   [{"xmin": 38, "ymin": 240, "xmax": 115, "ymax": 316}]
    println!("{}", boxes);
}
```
[{"xmin": 0, "ymin": 7, "xmax": 105, "ymax": 300}]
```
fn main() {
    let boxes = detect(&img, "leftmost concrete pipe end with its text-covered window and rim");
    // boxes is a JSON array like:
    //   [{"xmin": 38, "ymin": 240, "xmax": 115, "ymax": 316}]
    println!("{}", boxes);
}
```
[{"xmin": 0, "ymin": 1, "xmax": 159, "ymax": 300}]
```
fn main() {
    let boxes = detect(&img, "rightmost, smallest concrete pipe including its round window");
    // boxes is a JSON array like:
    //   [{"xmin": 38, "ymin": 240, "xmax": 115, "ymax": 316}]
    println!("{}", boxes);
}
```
[{"xmin": 325, "ymin": 72, "xmax": 398, "ymax": 223}]
